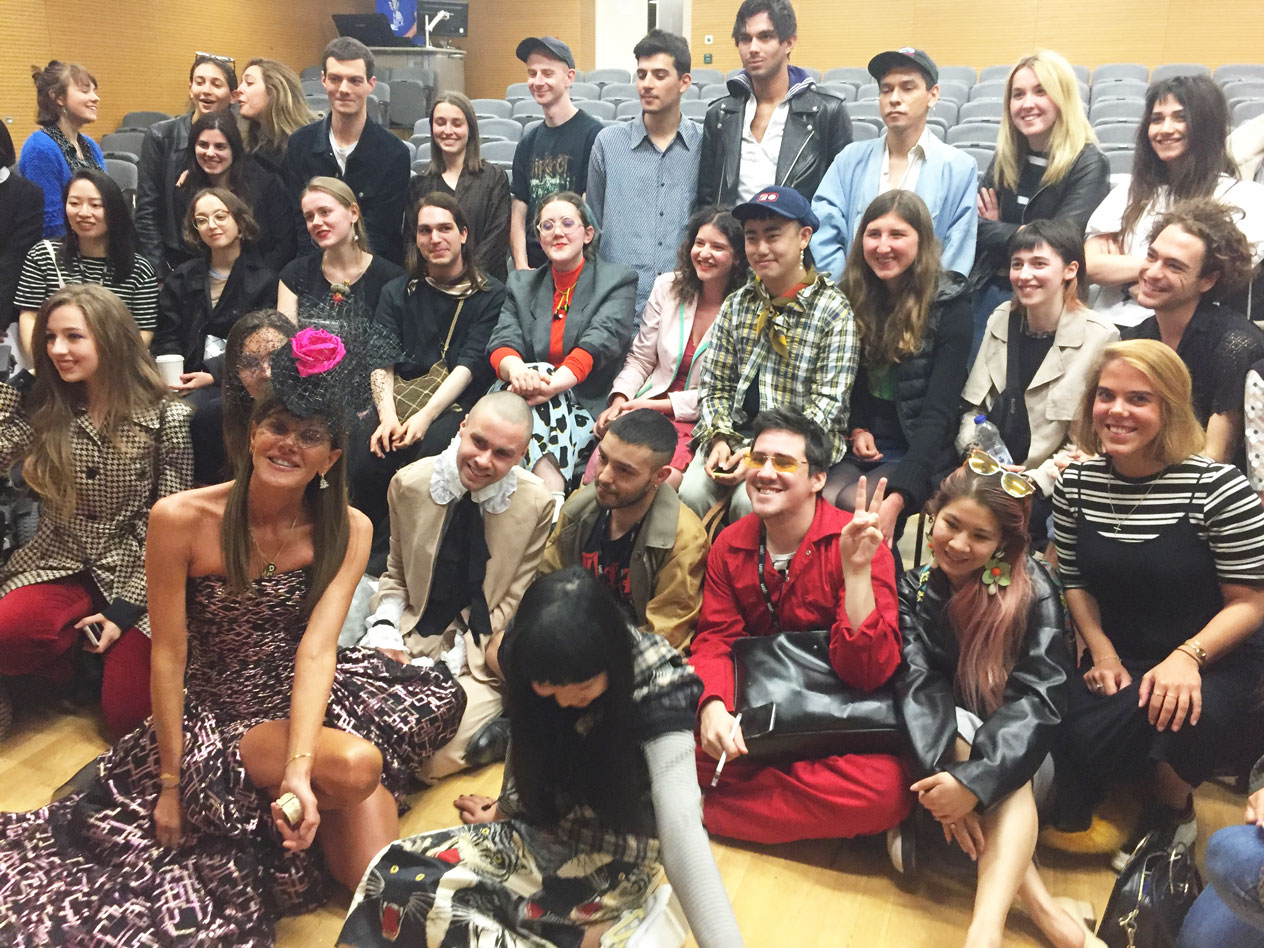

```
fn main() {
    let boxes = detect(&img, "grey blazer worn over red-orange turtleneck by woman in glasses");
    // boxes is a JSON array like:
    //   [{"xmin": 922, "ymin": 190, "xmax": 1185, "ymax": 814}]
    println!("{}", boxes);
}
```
[{"xmin": 487, "ymin": 259, "xmax": 636, "ymax": 418}]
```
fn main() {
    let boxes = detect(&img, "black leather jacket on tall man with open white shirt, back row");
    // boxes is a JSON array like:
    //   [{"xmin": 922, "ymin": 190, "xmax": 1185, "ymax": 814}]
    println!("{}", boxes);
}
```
[{"xmin": 695, "ymin": 66, "xmax": 852, "ymax": 207}]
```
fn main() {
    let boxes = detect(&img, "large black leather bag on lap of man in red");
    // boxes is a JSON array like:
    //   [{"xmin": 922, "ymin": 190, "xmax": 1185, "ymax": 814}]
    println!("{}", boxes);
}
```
[{"xmin": 733, "ymin": 631, "xmax": 904, "ymax": 761}]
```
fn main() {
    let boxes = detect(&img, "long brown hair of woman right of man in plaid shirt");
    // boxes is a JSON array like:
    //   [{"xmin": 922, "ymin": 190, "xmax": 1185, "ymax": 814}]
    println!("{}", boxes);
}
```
[{"xmin": 841, "ymin": 190, "xmax": 939, "ymax": 365}]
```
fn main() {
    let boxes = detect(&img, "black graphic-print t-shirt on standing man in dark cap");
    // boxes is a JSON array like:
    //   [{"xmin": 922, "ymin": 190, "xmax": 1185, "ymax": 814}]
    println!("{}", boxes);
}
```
[{"xmin": 509, "ymin": 109, "xmax": 604, "ymax": 254}]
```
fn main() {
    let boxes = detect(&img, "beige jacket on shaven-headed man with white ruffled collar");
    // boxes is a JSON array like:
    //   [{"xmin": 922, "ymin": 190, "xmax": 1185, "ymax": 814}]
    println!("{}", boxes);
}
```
[{"xmin": 369, "ymin": 458, "xmax": 554, "ymax": 680}]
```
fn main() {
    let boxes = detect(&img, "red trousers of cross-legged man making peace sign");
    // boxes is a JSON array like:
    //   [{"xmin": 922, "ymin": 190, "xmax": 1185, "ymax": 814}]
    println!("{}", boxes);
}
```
[{"xmin": 696, "ymin": 747, "xmax": 911, "ymax": 843}]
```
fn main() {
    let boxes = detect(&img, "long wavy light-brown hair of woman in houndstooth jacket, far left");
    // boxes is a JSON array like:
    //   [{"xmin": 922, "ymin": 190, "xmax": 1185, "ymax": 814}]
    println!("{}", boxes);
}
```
[{"xmin": 23, "ymin": 283, "xmax": 172, "ymax": 520}]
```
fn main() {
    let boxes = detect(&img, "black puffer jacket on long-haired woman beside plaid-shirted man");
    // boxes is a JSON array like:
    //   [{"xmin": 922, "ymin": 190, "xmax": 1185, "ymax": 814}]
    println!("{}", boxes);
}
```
[{"xmin": 851, "ymin": 272, "xmax": 972, "ymax": 513}]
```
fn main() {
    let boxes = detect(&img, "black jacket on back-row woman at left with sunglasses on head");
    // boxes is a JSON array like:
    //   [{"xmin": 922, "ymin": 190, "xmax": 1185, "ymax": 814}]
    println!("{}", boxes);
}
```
[{"xmin": 137, "ymin": 115, "xmax": 193, "ymax": 279}]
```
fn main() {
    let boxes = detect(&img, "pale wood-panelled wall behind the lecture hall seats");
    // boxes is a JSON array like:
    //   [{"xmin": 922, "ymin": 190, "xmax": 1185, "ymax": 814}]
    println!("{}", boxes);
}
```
[{"xmin": 0, "ymin": 0, "xmax": 1264, "ymax": 145}]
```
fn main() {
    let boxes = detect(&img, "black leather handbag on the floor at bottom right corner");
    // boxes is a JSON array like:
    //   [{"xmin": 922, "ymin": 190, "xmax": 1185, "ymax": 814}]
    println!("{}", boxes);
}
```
[{"xmin": 1097, "ymin": 830, "xmax": 1202, "ymax": 948}]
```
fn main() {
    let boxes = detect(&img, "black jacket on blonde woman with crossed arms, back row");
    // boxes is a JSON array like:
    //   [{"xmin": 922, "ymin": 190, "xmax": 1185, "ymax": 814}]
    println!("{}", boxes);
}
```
[{"xmin": 969, "ymin": 144, "xmax": 1110, "ymax": 288}]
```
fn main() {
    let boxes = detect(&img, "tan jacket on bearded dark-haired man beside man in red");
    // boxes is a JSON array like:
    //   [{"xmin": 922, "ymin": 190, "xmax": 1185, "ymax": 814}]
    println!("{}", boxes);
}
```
[{"xmin": 540, "ymin": 484, "xmax": 708, "ymax": 651}]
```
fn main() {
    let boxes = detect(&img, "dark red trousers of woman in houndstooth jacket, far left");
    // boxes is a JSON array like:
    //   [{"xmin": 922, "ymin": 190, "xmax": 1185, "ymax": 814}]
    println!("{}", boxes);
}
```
[{"xmin": 0, "ymin": 576, "xmax": 149, "ymax": 734}]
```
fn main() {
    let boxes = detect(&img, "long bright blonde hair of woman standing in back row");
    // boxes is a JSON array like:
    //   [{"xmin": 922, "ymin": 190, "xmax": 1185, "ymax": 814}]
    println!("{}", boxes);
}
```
[{"xmin": 995, "ymin": 49, "xmax": 1097, "ymax": 191}]
